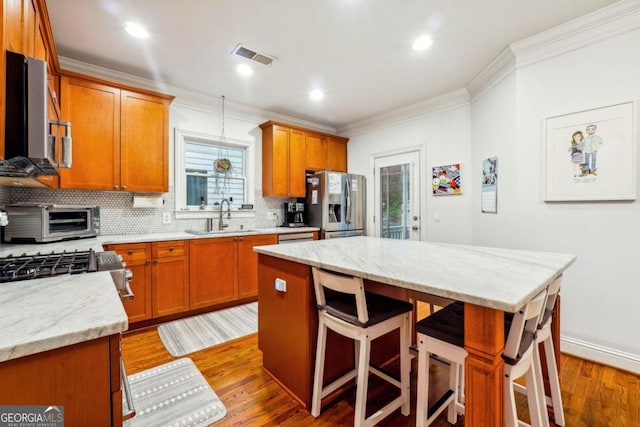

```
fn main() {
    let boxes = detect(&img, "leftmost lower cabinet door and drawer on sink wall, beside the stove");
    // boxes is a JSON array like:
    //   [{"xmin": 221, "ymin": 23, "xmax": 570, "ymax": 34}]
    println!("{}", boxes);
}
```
[{"xmin": 107, "ymin": 243, "xmax": 152, "ymax": 323}]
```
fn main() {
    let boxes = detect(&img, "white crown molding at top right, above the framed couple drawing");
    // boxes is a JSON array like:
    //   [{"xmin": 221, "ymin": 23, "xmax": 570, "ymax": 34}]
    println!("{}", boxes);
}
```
[{"xmin": 509, "ymin": 0, "xmax": 640, "ymax": 68}]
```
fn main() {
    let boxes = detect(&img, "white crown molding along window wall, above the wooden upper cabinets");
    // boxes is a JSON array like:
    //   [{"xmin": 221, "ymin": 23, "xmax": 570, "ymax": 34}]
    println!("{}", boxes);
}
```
[{"xmin": 59, "ymin": 56, "xmax": 336, "ymax": 134}]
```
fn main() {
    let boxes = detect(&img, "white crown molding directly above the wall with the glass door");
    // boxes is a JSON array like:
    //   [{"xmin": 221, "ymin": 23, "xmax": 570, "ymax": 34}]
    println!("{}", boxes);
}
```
[{"xmin": 338, "ymin": 88, "xmax": 469, "ymax": 138}]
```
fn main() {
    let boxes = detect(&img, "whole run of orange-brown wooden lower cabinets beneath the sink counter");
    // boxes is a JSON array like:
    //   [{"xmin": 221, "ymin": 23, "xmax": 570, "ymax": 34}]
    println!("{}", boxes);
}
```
[{"xmin": 106, "ymin": 234, "xmax": 278, "ymax": 323}]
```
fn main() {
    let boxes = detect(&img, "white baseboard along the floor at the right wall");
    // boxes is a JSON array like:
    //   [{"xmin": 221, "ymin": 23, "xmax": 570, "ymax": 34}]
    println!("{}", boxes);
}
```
[{"xmin": 560, "ymin": 336, "xmax": 640, "ymax": 374}]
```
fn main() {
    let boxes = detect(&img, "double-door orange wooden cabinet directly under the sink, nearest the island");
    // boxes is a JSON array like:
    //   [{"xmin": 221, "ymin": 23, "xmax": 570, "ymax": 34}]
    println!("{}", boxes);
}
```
[{"xmin": 189, "ymin": 234, "xmax": 278, "ymax": 310}]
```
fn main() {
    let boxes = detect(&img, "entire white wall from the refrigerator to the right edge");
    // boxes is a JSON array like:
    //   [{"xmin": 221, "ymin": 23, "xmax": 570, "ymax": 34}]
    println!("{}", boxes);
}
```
[{"xmin": 348, "ymin": 25, "xmax": 640, "ymax": 372}]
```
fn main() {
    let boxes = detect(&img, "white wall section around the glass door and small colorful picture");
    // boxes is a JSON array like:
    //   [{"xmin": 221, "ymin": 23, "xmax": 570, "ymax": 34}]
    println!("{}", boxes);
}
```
[{"xmin": 348, "ymin": 105, "xmax": 478, "ymax": 244}]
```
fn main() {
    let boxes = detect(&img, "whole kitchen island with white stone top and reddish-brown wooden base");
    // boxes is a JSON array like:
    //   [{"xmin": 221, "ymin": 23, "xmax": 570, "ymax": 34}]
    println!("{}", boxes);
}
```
[{"xmin": 254, "ymin": 236, "xmax": 575, "ymax": 427}]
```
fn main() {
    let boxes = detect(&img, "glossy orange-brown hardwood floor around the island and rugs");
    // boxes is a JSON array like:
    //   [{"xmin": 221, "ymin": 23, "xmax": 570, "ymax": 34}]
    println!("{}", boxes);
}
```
[{"xmin": 122, "ymin": 327, "xmax": 640, "ymax": 427}]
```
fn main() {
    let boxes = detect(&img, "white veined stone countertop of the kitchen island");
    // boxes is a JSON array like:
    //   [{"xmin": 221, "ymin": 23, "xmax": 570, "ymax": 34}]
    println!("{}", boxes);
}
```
[{"xmin": 254, "ymin": 236, "xmax": 576, "ymax": 312}]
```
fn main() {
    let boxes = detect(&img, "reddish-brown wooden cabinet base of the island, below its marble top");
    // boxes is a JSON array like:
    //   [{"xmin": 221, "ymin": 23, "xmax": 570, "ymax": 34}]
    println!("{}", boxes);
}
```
[{"xmin": 258, "ymin": 254, "xmax": 399, "ymax": 409}]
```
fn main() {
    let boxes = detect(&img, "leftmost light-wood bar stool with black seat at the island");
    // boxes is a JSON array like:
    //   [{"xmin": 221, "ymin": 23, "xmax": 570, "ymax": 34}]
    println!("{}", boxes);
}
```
[{"xmin": 311, "ymin": 267, "xmax": 413, "ymax": 427}]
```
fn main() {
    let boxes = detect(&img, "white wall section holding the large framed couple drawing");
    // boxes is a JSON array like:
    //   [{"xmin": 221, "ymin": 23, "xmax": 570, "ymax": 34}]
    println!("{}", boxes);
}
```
[{"xmin": 510, "ymin": 30, "xmax": 640, "ymax": 372}]
